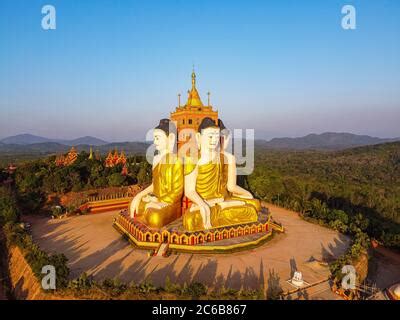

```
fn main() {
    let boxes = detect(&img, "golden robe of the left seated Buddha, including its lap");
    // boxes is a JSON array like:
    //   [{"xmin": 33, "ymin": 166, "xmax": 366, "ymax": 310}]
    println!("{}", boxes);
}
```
[{"xmin": 137, "ymin": 154, "xmax": 184, "ymax": 229}]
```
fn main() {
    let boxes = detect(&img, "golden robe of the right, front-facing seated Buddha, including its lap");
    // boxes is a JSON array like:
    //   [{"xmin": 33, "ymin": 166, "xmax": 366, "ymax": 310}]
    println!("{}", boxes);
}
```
[{"xmin": 183, "ymin": 157, "xmax": 259, "ymax": 231}]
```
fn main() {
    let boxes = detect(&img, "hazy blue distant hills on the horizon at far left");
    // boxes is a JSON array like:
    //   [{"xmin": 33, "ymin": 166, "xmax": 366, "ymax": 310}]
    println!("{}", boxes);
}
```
[{"xmin": 0, "ymin": 133, "xmax": 108, "ymax": 146}]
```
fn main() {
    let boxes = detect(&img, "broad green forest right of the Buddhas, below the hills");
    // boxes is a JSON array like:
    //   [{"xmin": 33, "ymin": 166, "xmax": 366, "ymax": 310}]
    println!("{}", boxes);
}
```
[{"xmin": 244, "ymin": 142, "xmax": 400, "ymax": 248}]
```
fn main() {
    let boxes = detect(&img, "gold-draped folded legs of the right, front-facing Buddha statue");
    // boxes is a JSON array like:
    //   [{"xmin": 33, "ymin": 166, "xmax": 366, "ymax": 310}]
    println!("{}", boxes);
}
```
[{"xmin": 183, "ymin": 204, "xmax": 258, "ymax": 231}]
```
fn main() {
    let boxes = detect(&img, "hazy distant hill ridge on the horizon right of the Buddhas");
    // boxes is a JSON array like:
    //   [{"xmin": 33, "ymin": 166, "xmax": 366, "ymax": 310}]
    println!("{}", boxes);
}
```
[{"xmin": 255, "ymin": 132, "xmax": 400, "ymax": 150}]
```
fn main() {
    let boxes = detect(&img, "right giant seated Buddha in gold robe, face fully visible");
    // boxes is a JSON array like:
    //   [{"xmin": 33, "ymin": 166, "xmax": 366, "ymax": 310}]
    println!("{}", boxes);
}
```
[{"xmin": 183, "ymin": 118, "xmax": 258, "ymax": 231}]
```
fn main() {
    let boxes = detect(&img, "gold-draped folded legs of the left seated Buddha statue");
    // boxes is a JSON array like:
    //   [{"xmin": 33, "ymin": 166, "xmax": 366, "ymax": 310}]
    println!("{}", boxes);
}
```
[{"xmin": 137, "ymin": 200, "xmax": 181, "ymax": 229}]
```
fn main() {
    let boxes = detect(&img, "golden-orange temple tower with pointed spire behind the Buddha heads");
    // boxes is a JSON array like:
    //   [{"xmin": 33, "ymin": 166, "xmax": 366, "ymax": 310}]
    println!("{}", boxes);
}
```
[{"xmin": 171, "ymin": 71, "xmax": 218, "ymax": 149}]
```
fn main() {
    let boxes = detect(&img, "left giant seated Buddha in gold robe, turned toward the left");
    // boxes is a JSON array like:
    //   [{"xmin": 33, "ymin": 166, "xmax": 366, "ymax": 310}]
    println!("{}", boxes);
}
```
[{"xmin": 129, "ymin": 119, "xmax": 184, "ymax": 229}]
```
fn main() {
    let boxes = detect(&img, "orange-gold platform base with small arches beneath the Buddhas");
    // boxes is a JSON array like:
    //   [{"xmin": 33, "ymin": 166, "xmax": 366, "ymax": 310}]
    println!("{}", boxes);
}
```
[{"xmin": 114, "ymin": 209, "xmax": 283, "ymax": 256}]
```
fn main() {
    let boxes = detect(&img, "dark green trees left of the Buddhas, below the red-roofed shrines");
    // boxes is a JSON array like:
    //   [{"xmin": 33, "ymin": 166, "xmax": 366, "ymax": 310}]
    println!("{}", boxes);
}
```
[{"xmin": 0, "ymin": 151, "xmax": 151, "ymax": 223}]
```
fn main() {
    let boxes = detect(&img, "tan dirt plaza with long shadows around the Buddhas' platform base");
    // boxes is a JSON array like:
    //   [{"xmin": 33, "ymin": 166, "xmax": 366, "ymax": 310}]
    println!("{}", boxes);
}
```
[{"xmin": 26, "ymin": 205, "xmax": 350, "ymax": 298}]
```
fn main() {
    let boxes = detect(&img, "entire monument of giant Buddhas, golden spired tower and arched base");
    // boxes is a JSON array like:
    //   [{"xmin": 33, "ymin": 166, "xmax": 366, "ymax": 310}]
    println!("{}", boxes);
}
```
[{"xmin": 113, "ymin": 71, "xmax": 283, "ymax": 252}]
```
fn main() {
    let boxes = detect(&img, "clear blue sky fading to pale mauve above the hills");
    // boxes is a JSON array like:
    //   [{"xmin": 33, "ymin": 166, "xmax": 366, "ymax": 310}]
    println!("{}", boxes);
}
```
[{"xmin": 0, "ymin": 0, "xmax": 400, "ymax": 141}]
